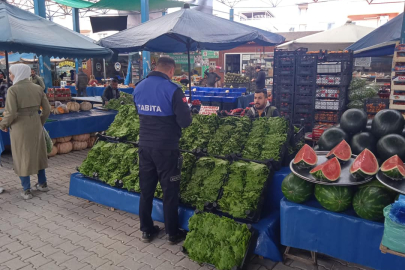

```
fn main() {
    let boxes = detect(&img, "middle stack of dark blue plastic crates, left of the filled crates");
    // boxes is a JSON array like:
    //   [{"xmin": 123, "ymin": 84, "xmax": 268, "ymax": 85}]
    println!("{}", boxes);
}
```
[{"xmin": 293, "ymin": 53, "xmax": 318, "ymax": 132}]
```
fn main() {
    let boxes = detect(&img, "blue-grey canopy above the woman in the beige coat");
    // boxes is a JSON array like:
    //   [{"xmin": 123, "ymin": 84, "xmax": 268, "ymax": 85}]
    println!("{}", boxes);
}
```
[{"xmin": 0, "ymin": 1, "xmax": 112, "ymax": 58}]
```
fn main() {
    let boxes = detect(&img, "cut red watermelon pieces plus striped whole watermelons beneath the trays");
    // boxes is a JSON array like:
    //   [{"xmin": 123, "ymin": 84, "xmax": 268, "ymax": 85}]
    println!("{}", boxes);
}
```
[{"xmin": 282, "ymin": 140, "xmax": 405, "ymax": 221}]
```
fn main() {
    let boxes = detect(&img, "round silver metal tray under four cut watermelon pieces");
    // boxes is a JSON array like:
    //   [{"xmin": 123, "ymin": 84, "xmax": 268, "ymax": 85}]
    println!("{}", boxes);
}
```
[{"xmin": 290, "ymin": 151, "xmax": 373, "ymax": 186}]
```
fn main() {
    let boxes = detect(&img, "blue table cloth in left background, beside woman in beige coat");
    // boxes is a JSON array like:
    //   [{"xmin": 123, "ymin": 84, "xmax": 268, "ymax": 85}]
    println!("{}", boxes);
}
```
[{"xmin": 0, "ymin": 109, "xmax": 117, "ymax": 147}]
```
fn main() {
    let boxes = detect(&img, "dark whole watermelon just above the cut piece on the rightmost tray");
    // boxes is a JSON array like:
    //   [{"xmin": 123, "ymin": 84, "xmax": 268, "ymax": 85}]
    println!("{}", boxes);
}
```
[{"xmin": 377, "ymin": 134, "xmax": 405, "ymax": 160}]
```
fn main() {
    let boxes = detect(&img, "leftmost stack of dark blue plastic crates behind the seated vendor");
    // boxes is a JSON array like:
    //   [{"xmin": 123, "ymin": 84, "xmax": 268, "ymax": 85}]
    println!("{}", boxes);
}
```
[{"xmin": 273, "ymin": 49, "xmax": 296, "ymax": 119}]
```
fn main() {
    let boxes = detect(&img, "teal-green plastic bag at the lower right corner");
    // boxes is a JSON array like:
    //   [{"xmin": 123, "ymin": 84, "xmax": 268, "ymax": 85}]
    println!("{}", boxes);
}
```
[{"xmin": 382, "ymin": 205, "xmax": 405, "ymax": 253}]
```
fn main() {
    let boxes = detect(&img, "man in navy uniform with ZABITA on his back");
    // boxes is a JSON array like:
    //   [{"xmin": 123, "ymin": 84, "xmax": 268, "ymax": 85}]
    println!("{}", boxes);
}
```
[{"xmin": 133, "ymin": 57, "xmax": 192, "ymax": 244}]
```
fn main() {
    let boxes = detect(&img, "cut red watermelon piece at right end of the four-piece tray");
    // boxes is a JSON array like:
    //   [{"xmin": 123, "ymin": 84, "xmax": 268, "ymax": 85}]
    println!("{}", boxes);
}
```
[{"xmin": 350, "ymin": 149, "xmax": 379, "ymax": 179}]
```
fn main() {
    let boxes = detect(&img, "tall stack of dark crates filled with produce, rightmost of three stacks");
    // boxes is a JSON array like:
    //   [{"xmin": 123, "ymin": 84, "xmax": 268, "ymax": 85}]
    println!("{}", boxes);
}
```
[{"xmin": 315, "ymin": 51, "xmax": 353, "ymax": 125}]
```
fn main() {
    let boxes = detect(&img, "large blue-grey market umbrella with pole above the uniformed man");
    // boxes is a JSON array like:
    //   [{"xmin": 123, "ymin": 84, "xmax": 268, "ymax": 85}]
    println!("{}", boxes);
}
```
[{"xmin": 99, "ymin": 4, "xmax": 285, "ymax": 93}]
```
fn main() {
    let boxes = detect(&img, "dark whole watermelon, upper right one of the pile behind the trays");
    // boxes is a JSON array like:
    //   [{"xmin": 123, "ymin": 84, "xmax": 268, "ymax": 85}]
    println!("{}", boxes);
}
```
[{"xmin": 371, "ymin": 109, "xmax": 405, "ymax": 139}]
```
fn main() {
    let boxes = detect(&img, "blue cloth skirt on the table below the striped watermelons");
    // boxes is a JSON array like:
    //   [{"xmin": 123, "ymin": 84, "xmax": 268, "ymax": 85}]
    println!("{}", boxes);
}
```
[{"xmin": 280, "ymin": 198, "xmax": 405, "ymax": 270}]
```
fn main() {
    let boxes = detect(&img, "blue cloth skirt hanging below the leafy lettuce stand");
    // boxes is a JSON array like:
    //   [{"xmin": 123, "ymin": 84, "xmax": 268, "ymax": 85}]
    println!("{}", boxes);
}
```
[{"xmin": 69, "ymin": 168, "xmax": 290, "ymax": 261}]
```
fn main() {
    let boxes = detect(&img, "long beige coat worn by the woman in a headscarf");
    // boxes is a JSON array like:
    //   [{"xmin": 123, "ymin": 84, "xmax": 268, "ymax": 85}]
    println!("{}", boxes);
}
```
[{"xmin": 0, "ymin": 79, "xmax": 51, "ymax": 176}]
